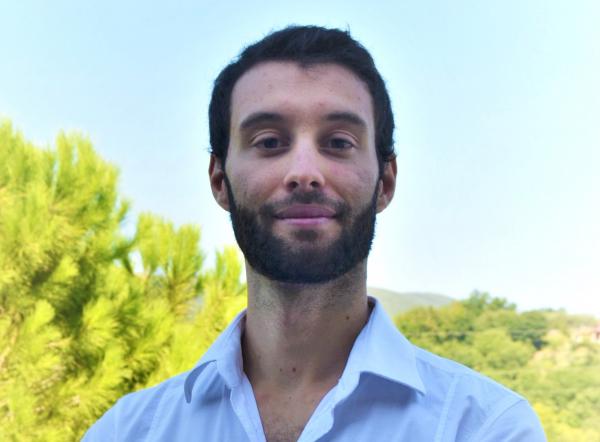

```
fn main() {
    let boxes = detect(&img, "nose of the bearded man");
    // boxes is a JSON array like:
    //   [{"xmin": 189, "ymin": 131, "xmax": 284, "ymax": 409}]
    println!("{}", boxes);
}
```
[{"xmin": 284, "ymin": 140, "xmax": 325, "ymax": 191}]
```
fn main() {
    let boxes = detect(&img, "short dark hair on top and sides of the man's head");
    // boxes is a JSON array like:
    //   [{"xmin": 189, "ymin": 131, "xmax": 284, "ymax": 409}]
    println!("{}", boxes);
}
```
[{"xmin": 208, "ymin": 26, "xmax": 395, "ymax": 171}]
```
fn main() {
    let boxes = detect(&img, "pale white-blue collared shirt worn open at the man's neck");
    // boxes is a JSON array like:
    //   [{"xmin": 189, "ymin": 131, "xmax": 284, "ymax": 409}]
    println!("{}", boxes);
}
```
[{"xmin": 83, "ymin": 298, "xmax": 546, "ymax": 442}]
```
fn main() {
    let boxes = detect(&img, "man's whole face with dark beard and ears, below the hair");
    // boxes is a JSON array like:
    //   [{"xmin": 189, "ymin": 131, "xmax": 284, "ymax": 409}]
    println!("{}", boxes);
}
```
[{"xmin": 211, "ymin": 62, "xmax": 395, "ymax": 283}]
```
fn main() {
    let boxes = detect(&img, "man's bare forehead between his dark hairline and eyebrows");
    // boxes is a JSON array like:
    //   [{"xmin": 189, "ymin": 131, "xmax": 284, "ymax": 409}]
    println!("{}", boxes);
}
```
[{"xmin": 231, "ymin": 61, "xmax": 373, "ymax": 130}]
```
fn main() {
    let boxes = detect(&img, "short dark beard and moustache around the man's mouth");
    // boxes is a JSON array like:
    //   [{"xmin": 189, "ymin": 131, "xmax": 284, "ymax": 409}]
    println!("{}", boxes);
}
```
[{"xmin": 225, "ymin": 176, "xmax": 377, "ymax": 284}]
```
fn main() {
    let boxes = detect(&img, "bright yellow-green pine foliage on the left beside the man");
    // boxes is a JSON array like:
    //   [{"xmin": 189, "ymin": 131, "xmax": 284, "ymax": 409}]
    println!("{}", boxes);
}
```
[{"xmin": 0, "ymin": 123, "xmax": 245, "ymax": 441}]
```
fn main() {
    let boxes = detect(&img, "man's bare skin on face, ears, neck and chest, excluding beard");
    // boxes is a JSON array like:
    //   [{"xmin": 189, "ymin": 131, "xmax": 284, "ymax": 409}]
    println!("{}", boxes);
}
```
[{"xmin": 209, "ymin": 62, "xmax": 396, "ymax": 441}]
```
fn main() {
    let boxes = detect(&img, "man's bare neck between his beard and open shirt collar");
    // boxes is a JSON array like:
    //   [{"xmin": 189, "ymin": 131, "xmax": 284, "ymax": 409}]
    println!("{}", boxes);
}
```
[{"xmin": 242, "ymin": 260, "xmax": 369, "ymax": 390}]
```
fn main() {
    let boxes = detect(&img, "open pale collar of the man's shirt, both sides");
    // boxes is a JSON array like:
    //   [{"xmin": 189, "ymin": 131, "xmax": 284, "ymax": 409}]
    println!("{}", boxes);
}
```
[{"xmin": 184, "ymin": 297, "xmax": 426, "ymax": 403}]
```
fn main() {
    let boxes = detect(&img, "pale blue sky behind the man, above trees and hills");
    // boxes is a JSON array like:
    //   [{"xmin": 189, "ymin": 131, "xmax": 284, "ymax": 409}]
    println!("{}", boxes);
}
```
[{"xmin": 0, "ymin": 0, "xmax": 600, "ymax": 316}]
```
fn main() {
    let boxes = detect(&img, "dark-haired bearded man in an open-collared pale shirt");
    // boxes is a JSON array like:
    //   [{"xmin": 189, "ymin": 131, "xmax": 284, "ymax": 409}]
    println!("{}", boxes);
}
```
[{"xmin": 86, "ymin": 27, "xmax": 545, "ymax": 442}]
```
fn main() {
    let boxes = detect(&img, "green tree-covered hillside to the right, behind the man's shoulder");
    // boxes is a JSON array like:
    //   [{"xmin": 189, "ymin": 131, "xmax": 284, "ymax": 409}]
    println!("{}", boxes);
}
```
[{"xmin": 396, "ymin": 292, "xmax": 600, "ymax": 442}]
